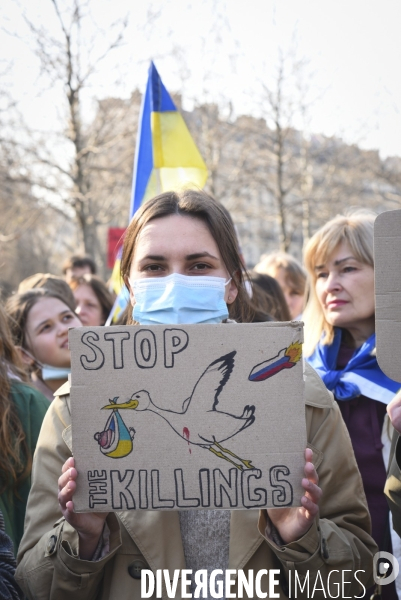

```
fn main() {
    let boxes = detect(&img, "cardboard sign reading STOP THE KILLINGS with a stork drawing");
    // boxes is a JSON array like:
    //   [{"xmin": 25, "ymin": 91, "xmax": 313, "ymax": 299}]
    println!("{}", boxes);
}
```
[{"xmin": 70, "ymin": 322, "xmax": 306, "ymax": 512}]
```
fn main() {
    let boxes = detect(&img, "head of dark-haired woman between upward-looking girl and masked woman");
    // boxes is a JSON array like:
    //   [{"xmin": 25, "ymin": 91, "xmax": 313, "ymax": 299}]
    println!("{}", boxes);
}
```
[{"xmin": 69, "ymin": 274, "xmax": 114, "ymax": 327}]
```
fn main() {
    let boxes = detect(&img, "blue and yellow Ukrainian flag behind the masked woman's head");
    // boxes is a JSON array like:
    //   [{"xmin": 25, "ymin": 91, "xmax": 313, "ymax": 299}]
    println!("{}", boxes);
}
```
[{"xmin": 106, "ymin": 62, "xmax": 207, "ymax": 325}]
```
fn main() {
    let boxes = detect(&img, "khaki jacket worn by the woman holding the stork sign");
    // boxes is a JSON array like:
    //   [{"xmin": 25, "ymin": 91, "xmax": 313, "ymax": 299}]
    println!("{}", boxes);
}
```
[{"xmin": 16, "ymin": 366, "xmax": 377, "ymax": 600}]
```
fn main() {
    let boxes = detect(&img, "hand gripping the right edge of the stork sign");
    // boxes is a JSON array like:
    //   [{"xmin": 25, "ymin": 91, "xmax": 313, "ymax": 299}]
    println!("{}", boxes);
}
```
[{"xmin": 267, "ymin": 448, "xmax": 322, "ymax": 544}]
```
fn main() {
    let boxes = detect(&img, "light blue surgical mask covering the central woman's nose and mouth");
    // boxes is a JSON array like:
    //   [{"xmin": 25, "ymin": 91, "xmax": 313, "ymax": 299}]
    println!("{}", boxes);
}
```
[{"xmin": 130, "ymin": 273, "xmax": 231, "ymax": 325}]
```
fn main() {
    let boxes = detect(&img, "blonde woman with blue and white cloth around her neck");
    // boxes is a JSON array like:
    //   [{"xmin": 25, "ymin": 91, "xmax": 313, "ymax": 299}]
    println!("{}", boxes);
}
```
[{"xmin": 303, "ymin": 213, "xmax": 401, "ymax": 598}]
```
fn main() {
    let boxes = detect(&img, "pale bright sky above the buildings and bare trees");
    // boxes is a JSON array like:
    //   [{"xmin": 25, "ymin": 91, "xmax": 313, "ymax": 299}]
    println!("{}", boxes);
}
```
[{"xmin": 0, "ymin": 0, "xmax": 401, "ymax": 157}]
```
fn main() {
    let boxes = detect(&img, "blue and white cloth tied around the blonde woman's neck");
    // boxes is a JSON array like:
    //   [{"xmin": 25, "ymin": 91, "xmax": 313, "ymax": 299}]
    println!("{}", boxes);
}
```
[{"xmin": 306, "ymin": 328, "xmax": 400, "ymax": 404}]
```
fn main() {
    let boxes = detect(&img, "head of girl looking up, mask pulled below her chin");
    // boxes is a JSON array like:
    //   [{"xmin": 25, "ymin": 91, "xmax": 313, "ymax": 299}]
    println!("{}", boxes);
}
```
[{"xmin": 6, "ymin": 288, "xmax": 82, "ymax": 401}]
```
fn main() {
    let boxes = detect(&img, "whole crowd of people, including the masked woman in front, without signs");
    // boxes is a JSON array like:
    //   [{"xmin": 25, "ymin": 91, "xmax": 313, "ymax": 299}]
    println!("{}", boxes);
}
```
[{"xmin": 0, "ymin": 190, "xmax": 401, "ymax": 600}]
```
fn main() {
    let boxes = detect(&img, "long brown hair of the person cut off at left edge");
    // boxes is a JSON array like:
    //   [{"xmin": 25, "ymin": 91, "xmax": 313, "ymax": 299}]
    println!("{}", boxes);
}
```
[{"xmin": 0, "ymin": 304, "xmax": 32, "ymax": 494}]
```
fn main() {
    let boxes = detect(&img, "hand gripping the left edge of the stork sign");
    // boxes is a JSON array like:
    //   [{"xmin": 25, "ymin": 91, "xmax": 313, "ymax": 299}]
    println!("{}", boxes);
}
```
[{"xmin": 58, "ymin": 457, "xmax": 108, "ymax": 560}]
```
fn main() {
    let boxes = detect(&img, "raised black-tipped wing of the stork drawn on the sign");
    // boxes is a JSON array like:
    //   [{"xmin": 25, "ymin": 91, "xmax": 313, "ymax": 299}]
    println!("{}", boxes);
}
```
[{"xmin": 184, "ymin": 350, "xmax": 237, "ymax": 411}]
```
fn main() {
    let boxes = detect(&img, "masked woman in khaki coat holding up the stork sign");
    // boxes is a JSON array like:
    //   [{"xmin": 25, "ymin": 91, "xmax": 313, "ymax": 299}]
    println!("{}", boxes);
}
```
[{"xmin": 16, "ymin": 190, "xmax": 375, "ymax": 600}]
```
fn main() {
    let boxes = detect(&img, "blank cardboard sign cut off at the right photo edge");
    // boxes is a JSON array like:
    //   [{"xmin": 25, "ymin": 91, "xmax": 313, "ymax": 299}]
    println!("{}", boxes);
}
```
[{"xmin": 374, "ymin": 210, "xmax": 401, "ymax": 382}]
